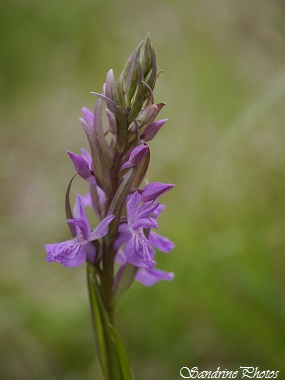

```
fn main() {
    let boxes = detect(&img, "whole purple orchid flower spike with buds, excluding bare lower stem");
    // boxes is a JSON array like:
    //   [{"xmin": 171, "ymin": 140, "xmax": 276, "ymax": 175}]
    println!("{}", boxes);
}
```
[{"xmin": 45, "ymin": 36, "xmax": 174, "ymax": 290}]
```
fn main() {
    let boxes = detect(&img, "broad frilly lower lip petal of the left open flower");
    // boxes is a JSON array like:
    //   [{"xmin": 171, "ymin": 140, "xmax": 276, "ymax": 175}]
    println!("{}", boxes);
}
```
[{"xmin": 45, "ymin": 239, "xmax": 86, "ymax": 267}]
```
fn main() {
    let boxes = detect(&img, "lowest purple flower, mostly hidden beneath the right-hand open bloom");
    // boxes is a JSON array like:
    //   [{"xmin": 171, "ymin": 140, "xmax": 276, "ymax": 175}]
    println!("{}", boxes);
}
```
[{"xmin": 116, "ymin": 249, "xmax": 174, "ymax": 286}]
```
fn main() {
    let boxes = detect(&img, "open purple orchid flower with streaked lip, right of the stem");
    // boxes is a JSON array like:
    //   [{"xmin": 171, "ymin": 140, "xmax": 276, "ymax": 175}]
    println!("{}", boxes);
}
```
[{"xmin": 115, "ymin": 191, "xmax": 174, "ymax": 270}]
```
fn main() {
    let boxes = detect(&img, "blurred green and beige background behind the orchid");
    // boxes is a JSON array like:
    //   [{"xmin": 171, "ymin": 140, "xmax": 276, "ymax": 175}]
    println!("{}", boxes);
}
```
[{"xmin": 0, "ymin": 0, "xmax": 285, "ymax": 380}]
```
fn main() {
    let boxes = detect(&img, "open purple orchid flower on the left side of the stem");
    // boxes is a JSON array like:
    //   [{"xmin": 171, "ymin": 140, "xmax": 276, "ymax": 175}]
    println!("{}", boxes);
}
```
[{"xmin": 45, "ymin": 194, "xmax": 114, "ymax": 267}]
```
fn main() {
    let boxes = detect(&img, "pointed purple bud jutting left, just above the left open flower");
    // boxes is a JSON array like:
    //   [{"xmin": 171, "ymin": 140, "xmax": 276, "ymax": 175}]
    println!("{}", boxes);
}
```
[{"xmin": 67, "ymin": 148, "xmax": 97, "ymax": 185}]
